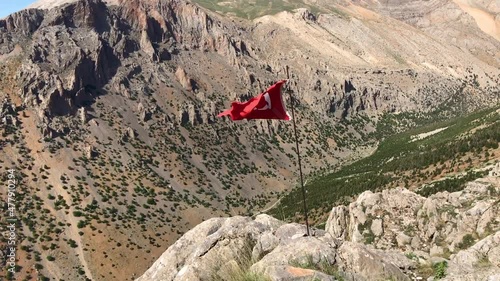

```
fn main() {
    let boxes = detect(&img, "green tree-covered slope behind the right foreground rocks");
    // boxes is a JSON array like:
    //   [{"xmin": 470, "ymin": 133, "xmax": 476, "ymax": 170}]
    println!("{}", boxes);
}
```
[{"xmin": 270, "ymin": 107, "xmax": 500, "ymax": 219}]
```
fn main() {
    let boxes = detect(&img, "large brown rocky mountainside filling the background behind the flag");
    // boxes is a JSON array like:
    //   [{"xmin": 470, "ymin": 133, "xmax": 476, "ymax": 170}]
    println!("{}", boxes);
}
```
[{"xmin": 0, "ymin": 0, "xmax": 500, "ymax": 280}]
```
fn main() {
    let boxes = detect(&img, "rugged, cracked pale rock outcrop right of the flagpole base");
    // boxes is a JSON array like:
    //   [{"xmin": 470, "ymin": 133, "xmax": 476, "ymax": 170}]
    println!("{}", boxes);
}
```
[{"xmin": 326, "ymin": 174, "xmax": 500, "ymax": 280}]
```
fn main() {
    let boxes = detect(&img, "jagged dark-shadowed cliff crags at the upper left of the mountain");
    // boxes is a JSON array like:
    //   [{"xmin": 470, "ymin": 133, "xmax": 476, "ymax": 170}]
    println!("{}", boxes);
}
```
[{"xmin": 0, "ymin": 0, "xmax": 249, "ymax": 126}]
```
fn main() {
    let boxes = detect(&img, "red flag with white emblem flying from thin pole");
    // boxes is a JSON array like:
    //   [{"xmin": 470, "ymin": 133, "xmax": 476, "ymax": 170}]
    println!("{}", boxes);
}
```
[{"xmin": 217, "ymin": 80, "xmax": 290, "ymax": 120}]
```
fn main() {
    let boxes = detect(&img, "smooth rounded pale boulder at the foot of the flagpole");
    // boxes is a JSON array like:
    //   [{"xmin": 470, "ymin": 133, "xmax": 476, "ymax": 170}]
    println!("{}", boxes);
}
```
[{"xmin": 137, "ymin": 212, "xmax": 412, "ymax": 281}]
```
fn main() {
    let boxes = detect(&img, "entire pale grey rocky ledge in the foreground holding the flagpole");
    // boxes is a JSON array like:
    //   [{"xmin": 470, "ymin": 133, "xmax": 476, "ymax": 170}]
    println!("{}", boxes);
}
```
[{"xmin": 137, "ymin": 176, "xmax": 500, "ymax": 281}]
